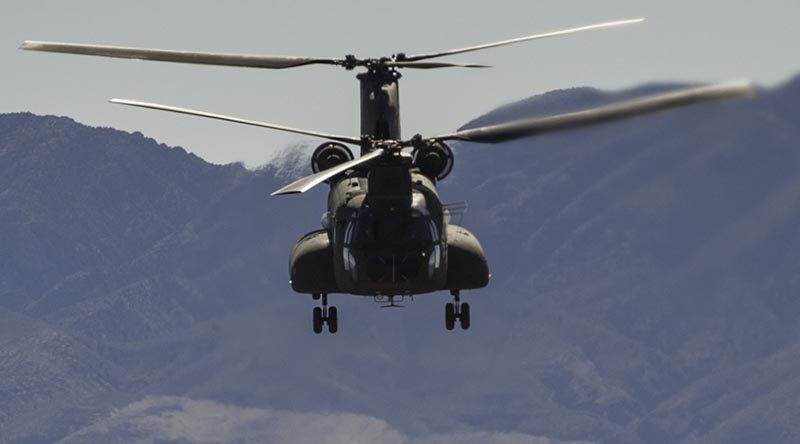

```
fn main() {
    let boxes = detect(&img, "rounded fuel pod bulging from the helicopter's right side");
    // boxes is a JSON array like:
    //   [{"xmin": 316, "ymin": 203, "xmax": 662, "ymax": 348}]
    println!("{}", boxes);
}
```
[{"xmin": 445, "ymin": 225, "xmax": 489, "ymax": 290}]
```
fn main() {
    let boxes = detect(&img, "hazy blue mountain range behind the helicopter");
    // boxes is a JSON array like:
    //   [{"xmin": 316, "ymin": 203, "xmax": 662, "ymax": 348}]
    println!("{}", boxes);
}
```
[{"xmin": 0, "ymin": 74, "xmax": 800, "ymax": 444}]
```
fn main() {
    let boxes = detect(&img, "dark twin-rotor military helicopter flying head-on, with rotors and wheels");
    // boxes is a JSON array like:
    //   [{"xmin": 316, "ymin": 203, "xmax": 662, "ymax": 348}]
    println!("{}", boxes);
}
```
[{"xmin": 21, "ymin": 19, "xmax": 753, "ymax": 333}]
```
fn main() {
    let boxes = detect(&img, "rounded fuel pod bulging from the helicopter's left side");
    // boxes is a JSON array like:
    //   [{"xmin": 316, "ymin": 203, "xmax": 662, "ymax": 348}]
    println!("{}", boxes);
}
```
[{"xmin": 289, "ymin": 230, "xmax": 339, "ymax": 293}]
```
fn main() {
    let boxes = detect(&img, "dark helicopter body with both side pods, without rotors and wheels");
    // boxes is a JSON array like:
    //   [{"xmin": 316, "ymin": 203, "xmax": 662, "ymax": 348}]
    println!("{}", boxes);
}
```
[{"xmin": 289, "ymin": 165, "xmax": 489, "ymax": 296}]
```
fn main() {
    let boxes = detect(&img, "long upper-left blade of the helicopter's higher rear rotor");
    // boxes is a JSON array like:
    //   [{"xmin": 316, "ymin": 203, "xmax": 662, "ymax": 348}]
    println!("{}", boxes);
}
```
[{"xmin": 19, "ymin": 40, "xmax": 341, "ymax": 69}]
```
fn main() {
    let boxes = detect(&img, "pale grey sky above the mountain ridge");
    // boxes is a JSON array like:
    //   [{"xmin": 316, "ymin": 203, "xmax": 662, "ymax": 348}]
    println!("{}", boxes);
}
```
[{"xmin": 0, "ymin": 0, "xmax": 800, "ymax": 167}]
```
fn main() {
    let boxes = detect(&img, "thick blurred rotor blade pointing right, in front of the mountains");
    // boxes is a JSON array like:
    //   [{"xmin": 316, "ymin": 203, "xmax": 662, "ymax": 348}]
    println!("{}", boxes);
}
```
[{"xmin": 433, "ymin": 81, "xmax": 755, "ymax": 143}]
